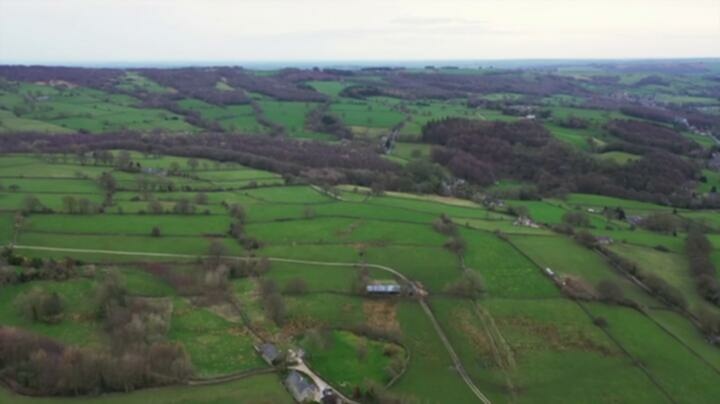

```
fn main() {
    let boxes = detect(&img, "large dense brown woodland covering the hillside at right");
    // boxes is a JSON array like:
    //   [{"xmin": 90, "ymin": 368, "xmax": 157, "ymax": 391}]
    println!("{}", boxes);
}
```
[{"xmin": 422, "ymin": 118, "xmax": 699, "ymax": 205}]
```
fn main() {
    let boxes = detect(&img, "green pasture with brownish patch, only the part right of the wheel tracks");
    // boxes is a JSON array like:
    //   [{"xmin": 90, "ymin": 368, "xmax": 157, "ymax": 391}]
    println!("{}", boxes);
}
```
[{"xmin": 482, "ymin": 299, "xmax": 663, "ymax": 403}]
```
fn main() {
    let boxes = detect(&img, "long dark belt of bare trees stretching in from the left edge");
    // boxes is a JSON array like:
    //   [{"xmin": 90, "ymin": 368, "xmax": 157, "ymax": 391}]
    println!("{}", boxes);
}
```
[{"xmin": 0, "ymin": 133, "xmax": 402, "ymax": 186}]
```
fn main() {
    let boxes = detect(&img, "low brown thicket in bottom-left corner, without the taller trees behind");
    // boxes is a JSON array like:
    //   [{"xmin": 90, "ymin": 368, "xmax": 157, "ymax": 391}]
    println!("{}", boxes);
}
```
[{"xmin": 0, "ymin": 327, "xmax": 192, "ymax": 395}]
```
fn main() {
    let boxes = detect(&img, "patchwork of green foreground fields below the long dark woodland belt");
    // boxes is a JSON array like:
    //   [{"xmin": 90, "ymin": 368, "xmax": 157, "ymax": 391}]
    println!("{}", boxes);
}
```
[{"xmin": 0, "ymin": 153, "xmax": 720, "ymax": 403}]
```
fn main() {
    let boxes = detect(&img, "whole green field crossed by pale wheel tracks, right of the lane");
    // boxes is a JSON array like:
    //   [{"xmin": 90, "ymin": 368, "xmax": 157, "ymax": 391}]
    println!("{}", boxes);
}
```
[{"xmin": 433, "ymin": 299, "xmax": 658, "ymax": 402}]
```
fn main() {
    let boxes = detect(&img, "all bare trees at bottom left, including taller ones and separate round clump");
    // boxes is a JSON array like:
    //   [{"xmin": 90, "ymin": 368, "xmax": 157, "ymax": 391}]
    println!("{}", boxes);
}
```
[{"xmin": 0, "ymin": 272, "xmax": 192, "ymax": 395}]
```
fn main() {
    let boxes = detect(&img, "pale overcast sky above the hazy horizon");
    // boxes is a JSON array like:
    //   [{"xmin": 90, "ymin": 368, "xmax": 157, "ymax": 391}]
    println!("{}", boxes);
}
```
[{"xmin": 0, "ymin": 0, "xmax": 720, "ymax": 64}]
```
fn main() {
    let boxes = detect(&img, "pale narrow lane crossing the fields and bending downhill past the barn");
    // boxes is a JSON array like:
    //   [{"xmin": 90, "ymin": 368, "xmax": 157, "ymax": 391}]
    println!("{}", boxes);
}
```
[{"xmin": 11, "ymin": 245, "xmax": 491, "ymax": 404}]
